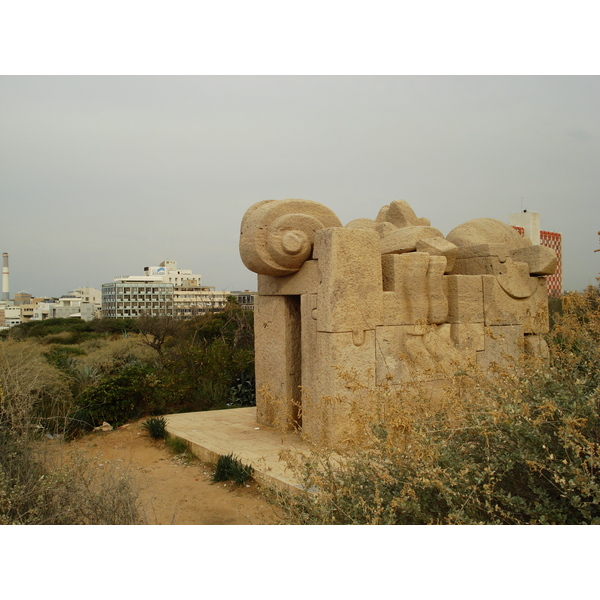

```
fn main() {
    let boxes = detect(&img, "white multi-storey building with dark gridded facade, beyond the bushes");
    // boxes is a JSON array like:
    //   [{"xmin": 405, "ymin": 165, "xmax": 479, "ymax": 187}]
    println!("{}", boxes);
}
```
[{"xmin": 102, "ymin": 275, "xmax": 174, "ymax": 319}]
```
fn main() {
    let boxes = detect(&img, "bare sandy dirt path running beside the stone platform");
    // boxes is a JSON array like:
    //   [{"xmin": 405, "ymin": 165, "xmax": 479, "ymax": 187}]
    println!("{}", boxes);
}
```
[{"xmin": 48, "ymin": 421, "xmax": 280, "ymax": 525}]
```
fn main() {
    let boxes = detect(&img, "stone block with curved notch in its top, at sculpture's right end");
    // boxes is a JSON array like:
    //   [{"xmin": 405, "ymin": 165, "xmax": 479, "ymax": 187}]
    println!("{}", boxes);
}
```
[{"xmin": 482, "ymin": 275, "xmax": 549, "ymax": 334}]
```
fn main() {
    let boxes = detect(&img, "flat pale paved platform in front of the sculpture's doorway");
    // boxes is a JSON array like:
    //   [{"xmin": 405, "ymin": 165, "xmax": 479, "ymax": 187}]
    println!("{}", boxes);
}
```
[{"xmin": 165, "ymin": 406, "xmax": 308, "ymax": 491}]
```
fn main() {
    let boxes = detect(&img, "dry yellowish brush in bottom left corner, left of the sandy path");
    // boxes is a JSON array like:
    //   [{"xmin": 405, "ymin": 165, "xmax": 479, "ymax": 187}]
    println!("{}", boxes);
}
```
[{"xmin": 0, "ymin": 342, "xmax": 142, "ymax": 525}]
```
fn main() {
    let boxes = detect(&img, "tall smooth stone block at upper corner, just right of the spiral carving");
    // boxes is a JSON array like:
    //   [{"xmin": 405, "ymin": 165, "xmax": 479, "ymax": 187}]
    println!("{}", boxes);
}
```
[{"xmin": 314, "ymin": 228, "xmax": 383, "ymax": 333}]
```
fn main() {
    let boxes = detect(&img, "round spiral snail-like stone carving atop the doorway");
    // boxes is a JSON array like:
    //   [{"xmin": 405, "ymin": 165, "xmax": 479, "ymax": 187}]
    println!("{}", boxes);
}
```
[{"xmin": 240, "ymin": 200, "xmax": 342, "ymax": 276}]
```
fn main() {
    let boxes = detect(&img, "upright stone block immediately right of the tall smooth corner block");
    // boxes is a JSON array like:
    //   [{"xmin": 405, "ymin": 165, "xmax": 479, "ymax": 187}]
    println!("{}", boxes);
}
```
[{"xmin": 381, "ymin": 252, "xmax": 430, "ymax": 325}]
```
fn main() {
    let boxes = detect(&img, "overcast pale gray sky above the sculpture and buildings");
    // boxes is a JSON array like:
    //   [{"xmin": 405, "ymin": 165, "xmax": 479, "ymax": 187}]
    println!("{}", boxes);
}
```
[{"xmin": 0, "ymin": 76, "xmax": 600, "ymax": 296}]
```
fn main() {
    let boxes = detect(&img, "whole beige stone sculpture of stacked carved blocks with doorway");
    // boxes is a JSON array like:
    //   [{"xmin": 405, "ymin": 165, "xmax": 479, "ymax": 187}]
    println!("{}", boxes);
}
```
[{"xmin": 240, "ymin": 200, "xmax": 556, "ymax": 447}]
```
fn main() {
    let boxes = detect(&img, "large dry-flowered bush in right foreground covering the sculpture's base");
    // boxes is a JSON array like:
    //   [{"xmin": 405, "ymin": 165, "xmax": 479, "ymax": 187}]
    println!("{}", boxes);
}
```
[{"xmin": 279, "ymin": 289, "xmax": 600, "ymax": 524}]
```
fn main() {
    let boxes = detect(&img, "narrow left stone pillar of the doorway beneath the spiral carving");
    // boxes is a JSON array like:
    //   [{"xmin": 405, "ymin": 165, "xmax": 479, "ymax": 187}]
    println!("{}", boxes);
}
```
[{"xmin": 254, "ymin": 296, "xmax": 302, "ymax": 429}]
